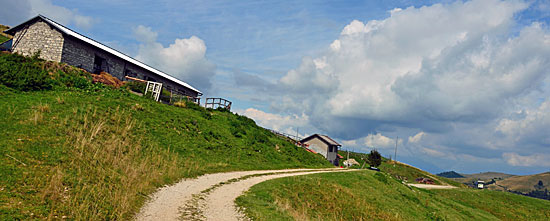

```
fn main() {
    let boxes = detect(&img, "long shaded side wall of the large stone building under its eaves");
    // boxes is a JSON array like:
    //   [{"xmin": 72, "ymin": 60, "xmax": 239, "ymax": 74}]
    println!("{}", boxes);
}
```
[{"xmin": 61, "ymin": 37, "xmax": 198, "ymax": 97}]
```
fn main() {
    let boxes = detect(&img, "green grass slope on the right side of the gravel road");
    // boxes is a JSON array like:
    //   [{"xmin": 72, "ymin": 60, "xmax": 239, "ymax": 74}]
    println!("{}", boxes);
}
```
[{"xmin": 236, "ymin": 170, "xmax": 550, "ymax": 220}]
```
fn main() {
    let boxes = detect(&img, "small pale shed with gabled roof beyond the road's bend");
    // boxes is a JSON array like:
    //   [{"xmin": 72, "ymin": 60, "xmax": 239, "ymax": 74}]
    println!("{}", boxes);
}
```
[{"xmin": 300, "ymin": 134, "xmax": 342, "ymax": 166}]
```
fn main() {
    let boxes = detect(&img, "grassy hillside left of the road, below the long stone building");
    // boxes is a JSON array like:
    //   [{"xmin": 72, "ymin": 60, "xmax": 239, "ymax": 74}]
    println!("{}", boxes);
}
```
[{"xmin": 0, "ymin": 53, "xmax": 332, "ymax": 220}]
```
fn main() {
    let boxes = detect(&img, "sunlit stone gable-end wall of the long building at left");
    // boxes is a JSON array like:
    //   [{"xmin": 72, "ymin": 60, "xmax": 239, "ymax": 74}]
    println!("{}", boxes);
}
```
[{"xmin": 12, "ymin": 21, "xmax": 64, "ymax": 62}]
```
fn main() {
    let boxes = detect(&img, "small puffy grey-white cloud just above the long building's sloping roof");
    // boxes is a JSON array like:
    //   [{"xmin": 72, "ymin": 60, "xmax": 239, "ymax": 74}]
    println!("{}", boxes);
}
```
[{"xmin": 134, "ymin": 25, "xmax": 216, "ymax": 92}]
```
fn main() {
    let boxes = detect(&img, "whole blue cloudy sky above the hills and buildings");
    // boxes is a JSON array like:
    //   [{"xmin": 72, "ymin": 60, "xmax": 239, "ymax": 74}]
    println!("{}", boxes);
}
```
[{"xmin": 0, "ymin": 0, "xmax": 550, "ymax": 174}]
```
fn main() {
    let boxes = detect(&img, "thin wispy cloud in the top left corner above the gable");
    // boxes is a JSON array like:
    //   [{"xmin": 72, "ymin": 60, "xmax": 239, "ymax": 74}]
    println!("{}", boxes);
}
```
[{"xmin": 0, "ymin": 0, "xmax": 96, "ymax": 29}]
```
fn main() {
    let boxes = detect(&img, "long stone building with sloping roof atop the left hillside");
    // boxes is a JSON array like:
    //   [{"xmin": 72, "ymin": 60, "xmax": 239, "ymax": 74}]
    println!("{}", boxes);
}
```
[{"xmin": 4, "ymin": 15, "xmax": 202, "ymax": 97}]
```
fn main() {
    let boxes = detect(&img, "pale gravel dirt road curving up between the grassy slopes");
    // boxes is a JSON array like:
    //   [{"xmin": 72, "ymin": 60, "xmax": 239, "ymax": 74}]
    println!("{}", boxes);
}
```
[{"xmin": 136, "ymin": 168, "xmax": 353, "ymax": 220}]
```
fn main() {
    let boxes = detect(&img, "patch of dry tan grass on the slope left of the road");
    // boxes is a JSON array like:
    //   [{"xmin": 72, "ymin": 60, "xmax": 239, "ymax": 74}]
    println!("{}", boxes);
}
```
[{"xmin": 43, "ymin": 109, "xmax": 193, "ymax": 220}]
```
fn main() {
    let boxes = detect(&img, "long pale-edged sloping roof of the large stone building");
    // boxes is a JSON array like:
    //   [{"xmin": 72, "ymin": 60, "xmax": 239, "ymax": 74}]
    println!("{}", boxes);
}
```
[{"xmin": 4, "ymin": 15, "xmax": 202, "ymax": 94}]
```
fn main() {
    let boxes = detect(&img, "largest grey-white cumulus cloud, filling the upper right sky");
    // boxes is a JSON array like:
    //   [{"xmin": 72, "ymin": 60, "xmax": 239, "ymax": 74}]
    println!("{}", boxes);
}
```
[{"xmin": 280, "ymin": 0, "xmax": 550, "ymax": 136}]
